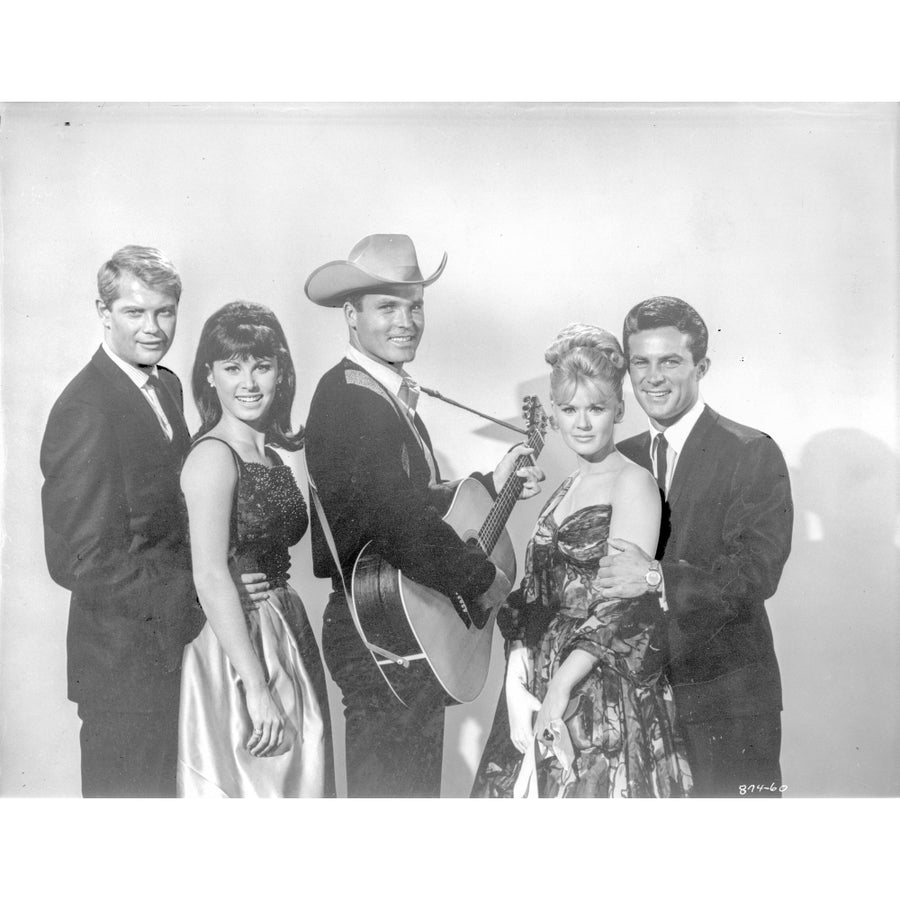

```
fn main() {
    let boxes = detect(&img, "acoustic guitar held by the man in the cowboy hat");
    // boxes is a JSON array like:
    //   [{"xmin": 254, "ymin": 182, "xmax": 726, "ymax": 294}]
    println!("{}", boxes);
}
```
[{"xmin": 350, "ymin": 396, "xmax": 547, "ymax": 705}]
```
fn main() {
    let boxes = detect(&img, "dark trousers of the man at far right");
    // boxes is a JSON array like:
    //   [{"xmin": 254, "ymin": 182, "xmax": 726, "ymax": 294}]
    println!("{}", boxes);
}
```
[{"xmin": 681, "ymin": 713, "xmax": 782, "ymax": 797}]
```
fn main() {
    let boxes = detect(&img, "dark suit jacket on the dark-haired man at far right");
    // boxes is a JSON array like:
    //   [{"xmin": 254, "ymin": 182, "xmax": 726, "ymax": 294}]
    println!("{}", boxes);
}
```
[{"xmin": 619, "ymin": 407, "xmax": 793, "ymax": 722}]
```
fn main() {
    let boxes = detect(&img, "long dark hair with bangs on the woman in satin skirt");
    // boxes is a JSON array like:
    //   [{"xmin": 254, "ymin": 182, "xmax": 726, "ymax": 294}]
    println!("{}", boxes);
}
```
[{"xmin": 191, "ymin": 300, "xmax": 303, "ymax": 450}]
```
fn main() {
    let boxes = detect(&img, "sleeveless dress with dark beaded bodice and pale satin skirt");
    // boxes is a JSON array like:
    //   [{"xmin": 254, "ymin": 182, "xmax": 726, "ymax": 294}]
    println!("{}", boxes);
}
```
[{"xmin": 178, "ymin": 437, "xmax": 334, "ymax": 797}]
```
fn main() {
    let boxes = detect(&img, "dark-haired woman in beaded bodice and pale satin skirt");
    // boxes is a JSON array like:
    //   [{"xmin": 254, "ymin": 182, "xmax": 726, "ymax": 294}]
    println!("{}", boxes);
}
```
[{"xmin": 178, "ymin": 302, "xmax": 334, "ymax": 797}]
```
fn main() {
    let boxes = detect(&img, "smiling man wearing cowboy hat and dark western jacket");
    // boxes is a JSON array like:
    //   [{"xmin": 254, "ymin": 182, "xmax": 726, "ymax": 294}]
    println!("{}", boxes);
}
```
[{"xmin": 306, "ymin": 234, "xmax": 544, "ymax": 797}]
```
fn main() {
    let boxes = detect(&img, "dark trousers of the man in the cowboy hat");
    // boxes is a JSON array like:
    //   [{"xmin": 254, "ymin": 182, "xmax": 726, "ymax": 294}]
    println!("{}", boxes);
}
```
[{"xmin": 322, "ymin": 594, "xmax": 444, "ymax": 797}]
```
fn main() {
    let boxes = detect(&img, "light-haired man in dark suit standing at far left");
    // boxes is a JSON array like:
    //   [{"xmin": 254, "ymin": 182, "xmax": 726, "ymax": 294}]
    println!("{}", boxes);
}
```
[{"xmin": 41, "ymin": 246, "xmax": 203, "ymax": 797}]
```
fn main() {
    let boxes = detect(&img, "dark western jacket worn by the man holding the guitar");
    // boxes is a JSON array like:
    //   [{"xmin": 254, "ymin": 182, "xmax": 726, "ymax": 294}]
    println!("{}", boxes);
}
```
[{"xmin": 306, "ymin": 359, "xmax": 495, "ymax": 600}]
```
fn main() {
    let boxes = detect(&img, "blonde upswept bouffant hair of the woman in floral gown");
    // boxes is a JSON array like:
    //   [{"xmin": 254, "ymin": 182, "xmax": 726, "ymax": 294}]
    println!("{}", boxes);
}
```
[{"xmin": 544, "ymin": 324, "xmax": 627, "ymax": 403}]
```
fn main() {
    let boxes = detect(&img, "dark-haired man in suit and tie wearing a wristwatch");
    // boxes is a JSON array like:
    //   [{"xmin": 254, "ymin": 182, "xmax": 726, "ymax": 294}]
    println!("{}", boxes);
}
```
[{"xmin": 600, "ymin": 297, "xmax": 793, "ymax": 797}]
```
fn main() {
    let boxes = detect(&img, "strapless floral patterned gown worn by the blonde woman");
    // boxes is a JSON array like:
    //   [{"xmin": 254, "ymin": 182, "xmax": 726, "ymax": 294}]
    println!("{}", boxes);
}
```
[{"xmin": 472, "ymin": 474, "xmax": 691, "ymax": 797}]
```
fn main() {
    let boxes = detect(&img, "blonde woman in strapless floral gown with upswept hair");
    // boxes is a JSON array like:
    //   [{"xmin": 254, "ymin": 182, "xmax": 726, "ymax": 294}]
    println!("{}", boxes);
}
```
[{"xmin": 472, "ymin": 325, "xmax": 691, "ymax": 797}]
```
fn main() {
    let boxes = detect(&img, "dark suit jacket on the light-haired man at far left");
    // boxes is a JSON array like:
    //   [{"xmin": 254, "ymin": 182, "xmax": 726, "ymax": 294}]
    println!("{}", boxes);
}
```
[{"xmin": 41, "ymin": 348, "xmax": 203, "ymax": 712}]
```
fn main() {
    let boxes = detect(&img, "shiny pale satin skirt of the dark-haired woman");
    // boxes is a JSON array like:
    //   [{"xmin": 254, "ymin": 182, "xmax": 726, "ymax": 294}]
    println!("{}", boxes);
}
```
[{"xmin": 177, "ymin": 586, "xmax": 333, "ymax": 797}]
